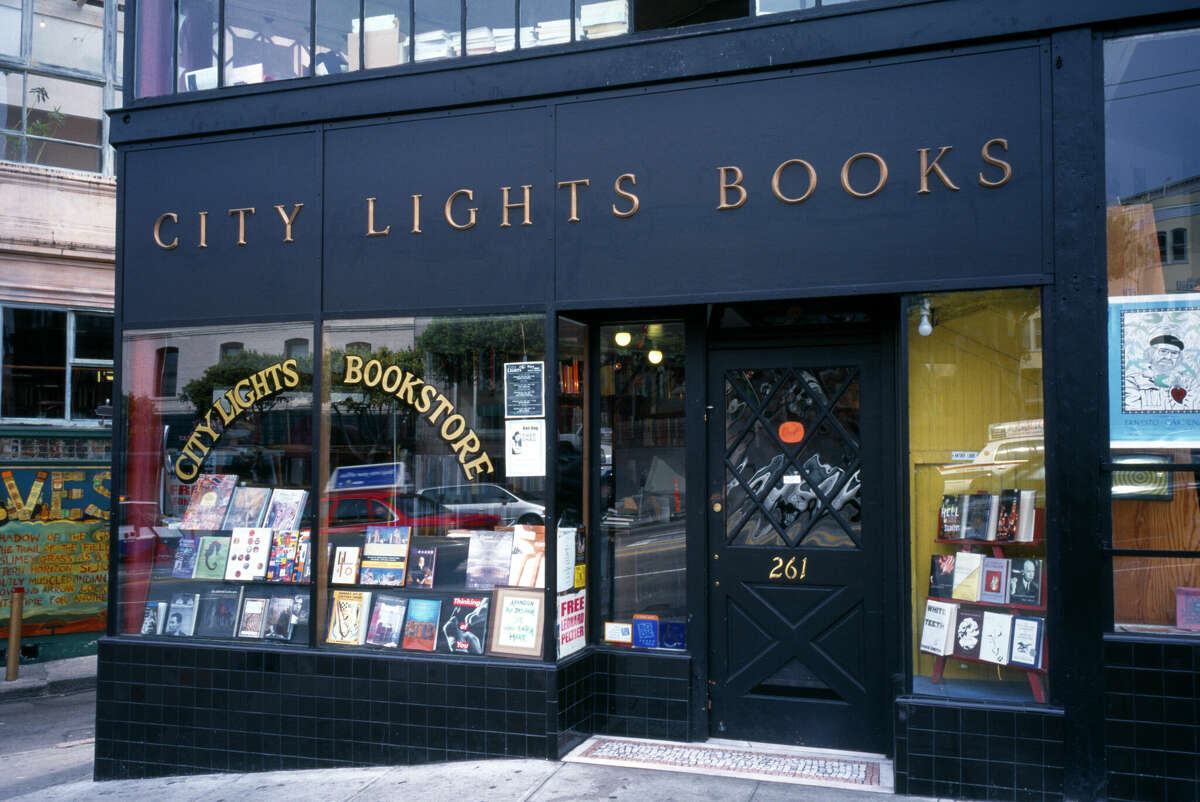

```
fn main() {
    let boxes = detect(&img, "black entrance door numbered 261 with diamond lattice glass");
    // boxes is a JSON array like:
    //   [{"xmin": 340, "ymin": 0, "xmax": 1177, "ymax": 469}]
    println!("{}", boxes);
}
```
[{"xmin": 708, "ymin": 346, "xmax": 890, "ymax": 752}]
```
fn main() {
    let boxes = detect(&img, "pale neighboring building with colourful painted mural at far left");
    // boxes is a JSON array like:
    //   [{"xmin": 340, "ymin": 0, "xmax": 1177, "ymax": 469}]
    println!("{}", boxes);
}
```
[{"xmin": 0, "ymin": 0, "xmax": 124, "ymax": 660}]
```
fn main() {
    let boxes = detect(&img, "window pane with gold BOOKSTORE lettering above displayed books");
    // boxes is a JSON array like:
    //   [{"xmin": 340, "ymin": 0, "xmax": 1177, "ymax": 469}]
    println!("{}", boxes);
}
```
[{"xmin": 317, "ymin": 315, "xmax": 553, "ymax": 657}]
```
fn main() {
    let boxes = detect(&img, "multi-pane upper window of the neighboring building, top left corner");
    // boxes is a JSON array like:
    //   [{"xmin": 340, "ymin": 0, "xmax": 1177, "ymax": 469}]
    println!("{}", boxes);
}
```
[{"xmin": 0, "ymin": 0, "xmax": 125, "ymax": 174}]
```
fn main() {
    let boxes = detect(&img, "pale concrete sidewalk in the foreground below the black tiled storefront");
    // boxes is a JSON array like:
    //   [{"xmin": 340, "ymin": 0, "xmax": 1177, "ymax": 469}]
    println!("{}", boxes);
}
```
[{"xmin": 16, "ymin": 760, "xmax": 940, "ymax": 802}]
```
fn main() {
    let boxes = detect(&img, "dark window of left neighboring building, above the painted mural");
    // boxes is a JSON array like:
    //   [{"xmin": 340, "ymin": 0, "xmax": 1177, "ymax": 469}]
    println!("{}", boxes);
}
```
[{"xmin": 0, "ymin": 306, "xmax": 113, "ymax": 421}]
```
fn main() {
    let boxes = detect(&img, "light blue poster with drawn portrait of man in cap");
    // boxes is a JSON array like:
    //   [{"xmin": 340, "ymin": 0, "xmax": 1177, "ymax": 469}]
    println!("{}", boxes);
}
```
[{"xmin": 1109, "ymin": 295, "xmax": 1200, "ymax": 448}]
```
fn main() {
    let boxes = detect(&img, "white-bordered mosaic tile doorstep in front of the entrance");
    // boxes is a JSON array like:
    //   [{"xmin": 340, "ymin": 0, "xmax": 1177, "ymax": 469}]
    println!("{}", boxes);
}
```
[{"xmin": 563, "ymin": 735, "xmax": 894, "ymax": 794}]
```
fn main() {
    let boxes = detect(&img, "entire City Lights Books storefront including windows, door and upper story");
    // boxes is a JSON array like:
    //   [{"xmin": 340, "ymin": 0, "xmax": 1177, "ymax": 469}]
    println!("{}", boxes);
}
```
[{"xmin": 96, "ymin": 0, "xmax": 1200, "ymax": 801}]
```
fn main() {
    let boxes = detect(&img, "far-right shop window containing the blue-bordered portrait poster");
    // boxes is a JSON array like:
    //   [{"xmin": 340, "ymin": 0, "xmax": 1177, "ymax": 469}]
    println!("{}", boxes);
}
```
[{"xmin": 1104, "ymin": 29, "xmax": 1200, "ymax": 635}]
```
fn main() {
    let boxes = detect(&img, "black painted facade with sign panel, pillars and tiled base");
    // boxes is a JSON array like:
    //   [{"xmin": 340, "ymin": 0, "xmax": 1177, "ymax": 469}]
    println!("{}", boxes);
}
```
[{"xmin": 96, "ymin": 0, "xmax": 1200, "ymax": 800}]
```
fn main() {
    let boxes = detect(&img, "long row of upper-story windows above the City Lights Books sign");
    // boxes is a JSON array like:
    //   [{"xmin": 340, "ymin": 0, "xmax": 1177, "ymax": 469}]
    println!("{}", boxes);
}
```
[{"xmin": 133, "ymin": 0, "xmax": 873, "ymax": 97}]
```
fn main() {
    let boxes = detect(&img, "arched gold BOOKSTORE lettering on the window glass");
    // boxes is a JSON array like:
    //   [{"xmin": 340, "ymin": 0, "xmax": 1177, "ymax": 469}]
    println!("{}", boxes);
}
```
[{"xmin": 342, "ymin": 354, "xmax": 496, "ymax": 480}]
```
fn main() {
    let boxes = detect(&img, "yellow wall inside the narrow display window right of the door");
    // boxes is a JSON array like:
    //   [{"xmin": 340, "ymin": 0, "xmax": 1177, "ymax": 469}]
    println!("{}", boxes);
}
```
[{"xmin": 908, "ymin": 289, "xmax": 1045, "ymax": 681}]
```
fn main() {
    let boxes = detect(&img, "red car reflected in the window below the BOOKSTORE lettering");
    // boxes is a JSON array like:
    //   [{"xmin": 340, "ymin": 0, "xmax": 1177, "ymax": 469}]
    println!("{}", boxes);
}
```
[{"xmin": 325, "ymin": 490, "xmax": 500, "ymax": 535}]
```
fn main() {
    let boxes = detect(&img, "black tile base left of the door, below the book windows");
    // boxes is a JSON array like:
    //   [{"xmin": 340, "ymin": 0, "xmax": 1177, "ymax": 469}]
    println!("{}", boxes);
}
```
[{"xmin": 95, "ymin": 639, "xmax": 690, "ymax": 779}]
